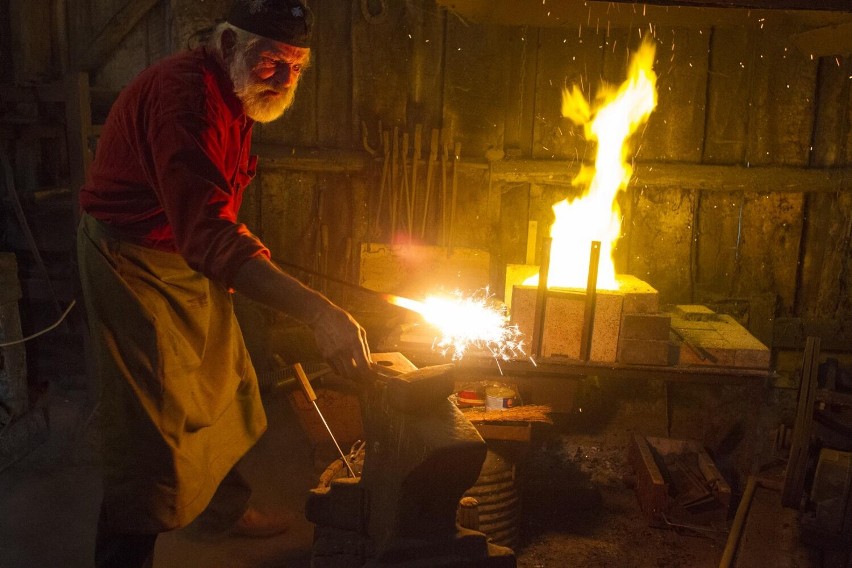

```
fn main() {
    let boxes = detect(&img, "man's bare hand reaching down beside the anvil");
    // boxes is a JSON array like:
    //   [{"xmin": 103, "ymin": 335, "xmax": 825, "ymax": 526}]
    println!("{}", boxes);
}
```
[{"xmin": 313, "ymin": 304, "xmax": 372, "ymax": 381}]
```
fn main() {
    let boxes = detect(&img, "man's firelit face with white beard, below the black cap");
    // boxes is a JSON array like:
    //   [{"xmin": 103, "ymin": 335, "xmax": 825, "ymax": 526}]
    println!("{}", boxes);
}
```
[{"xmin": 229, "ymin": 39, "xmax": 311, "ymax": 122}]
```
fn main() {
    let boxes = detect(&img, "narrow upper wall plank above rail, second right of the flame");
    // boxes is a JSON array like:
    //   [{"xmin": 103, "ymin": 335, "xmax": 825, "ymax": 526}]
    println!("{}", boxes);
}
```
[{"xmin": 702, "ymin": 27, "xmax": 751, "ymax": 164}]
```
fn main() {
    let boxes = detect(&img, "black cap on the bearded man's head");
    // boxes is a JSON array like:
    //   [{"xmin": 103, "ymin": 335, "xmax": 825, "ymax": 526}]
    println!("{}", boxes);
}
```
[{"xmin": 228, "ymin": 0, "xmax": 314, "ymax": 47}]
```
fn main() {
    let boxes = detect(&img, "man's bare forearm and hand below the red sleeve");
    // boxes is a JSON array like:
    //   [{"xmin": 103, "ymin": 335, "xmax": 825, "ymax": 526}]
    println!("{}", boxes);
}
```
[{"xmin": 232, "ymin": 256, "xmax": 370, "ymax": 380}]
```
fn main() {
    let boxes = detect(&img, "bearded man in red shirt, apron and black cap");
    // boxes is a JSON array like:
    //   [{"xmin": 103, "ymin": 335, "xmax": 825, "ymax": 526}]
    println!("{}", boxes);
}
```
[{"xmin": 78, "ymin": 0, "xmax": 369, "ymax": 568}]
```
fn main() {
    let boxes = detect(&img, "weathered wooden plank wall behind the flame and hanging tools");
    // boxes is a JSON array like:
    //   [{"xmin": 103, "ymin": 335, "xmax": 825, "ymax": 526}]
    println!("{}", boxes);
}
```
[{"xmin": 3, "ymin": 0, "xmax": 852, "ymax": 345}]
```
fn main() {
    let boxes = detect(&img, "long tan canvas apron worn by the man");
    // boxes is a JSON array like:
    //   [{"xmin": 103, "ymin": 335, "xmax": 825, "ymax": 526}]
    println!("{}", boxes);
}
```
[{"xmin": 77, "ymin": 215, "xmax": 266, "ymax": 533}]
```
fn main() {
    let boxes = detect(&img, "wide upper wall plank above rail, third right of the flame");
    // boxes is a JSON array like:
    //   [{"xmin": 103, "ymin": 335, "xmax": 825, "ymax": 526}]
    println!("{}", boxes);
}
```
[{"xmin": 745, "ymin": 24, "xmax": 817, "ymax": 165}]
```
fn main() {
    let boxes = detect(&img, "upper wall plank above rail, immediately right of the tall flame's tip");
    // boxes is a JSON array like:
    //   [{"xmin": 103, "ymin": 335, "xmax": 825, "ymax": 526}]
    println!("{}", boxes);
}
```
[{"xmin": 632, "ymin": 26, "xmax": 711, "ymax": 163}]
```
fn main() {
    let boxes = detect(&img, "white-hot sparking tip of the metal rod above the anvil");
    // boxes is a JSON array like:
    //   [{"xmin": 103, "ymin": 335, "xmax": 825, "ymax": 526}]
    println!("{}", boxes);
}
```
[{"xmin": 387, "ymin": 290, "xmax": 524, "ymax": 361}]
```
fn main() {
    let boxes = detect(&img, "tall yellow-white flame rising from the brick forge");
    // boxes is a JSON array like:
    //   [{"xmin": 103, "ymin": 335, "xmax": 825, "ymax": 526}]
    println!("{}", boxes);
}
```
[{"xmin": 524, "ymin": 37, "xmax": 657, "ymax": 290}]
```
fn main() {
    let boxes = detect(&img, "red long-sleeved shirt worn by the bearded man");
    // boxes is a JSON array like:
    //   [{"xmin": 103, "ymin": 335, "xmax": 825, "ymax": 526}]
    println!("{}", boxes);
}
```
[{"xmin": 80, "ymin": 48, "xmax": 269, "ymax": 286}]
